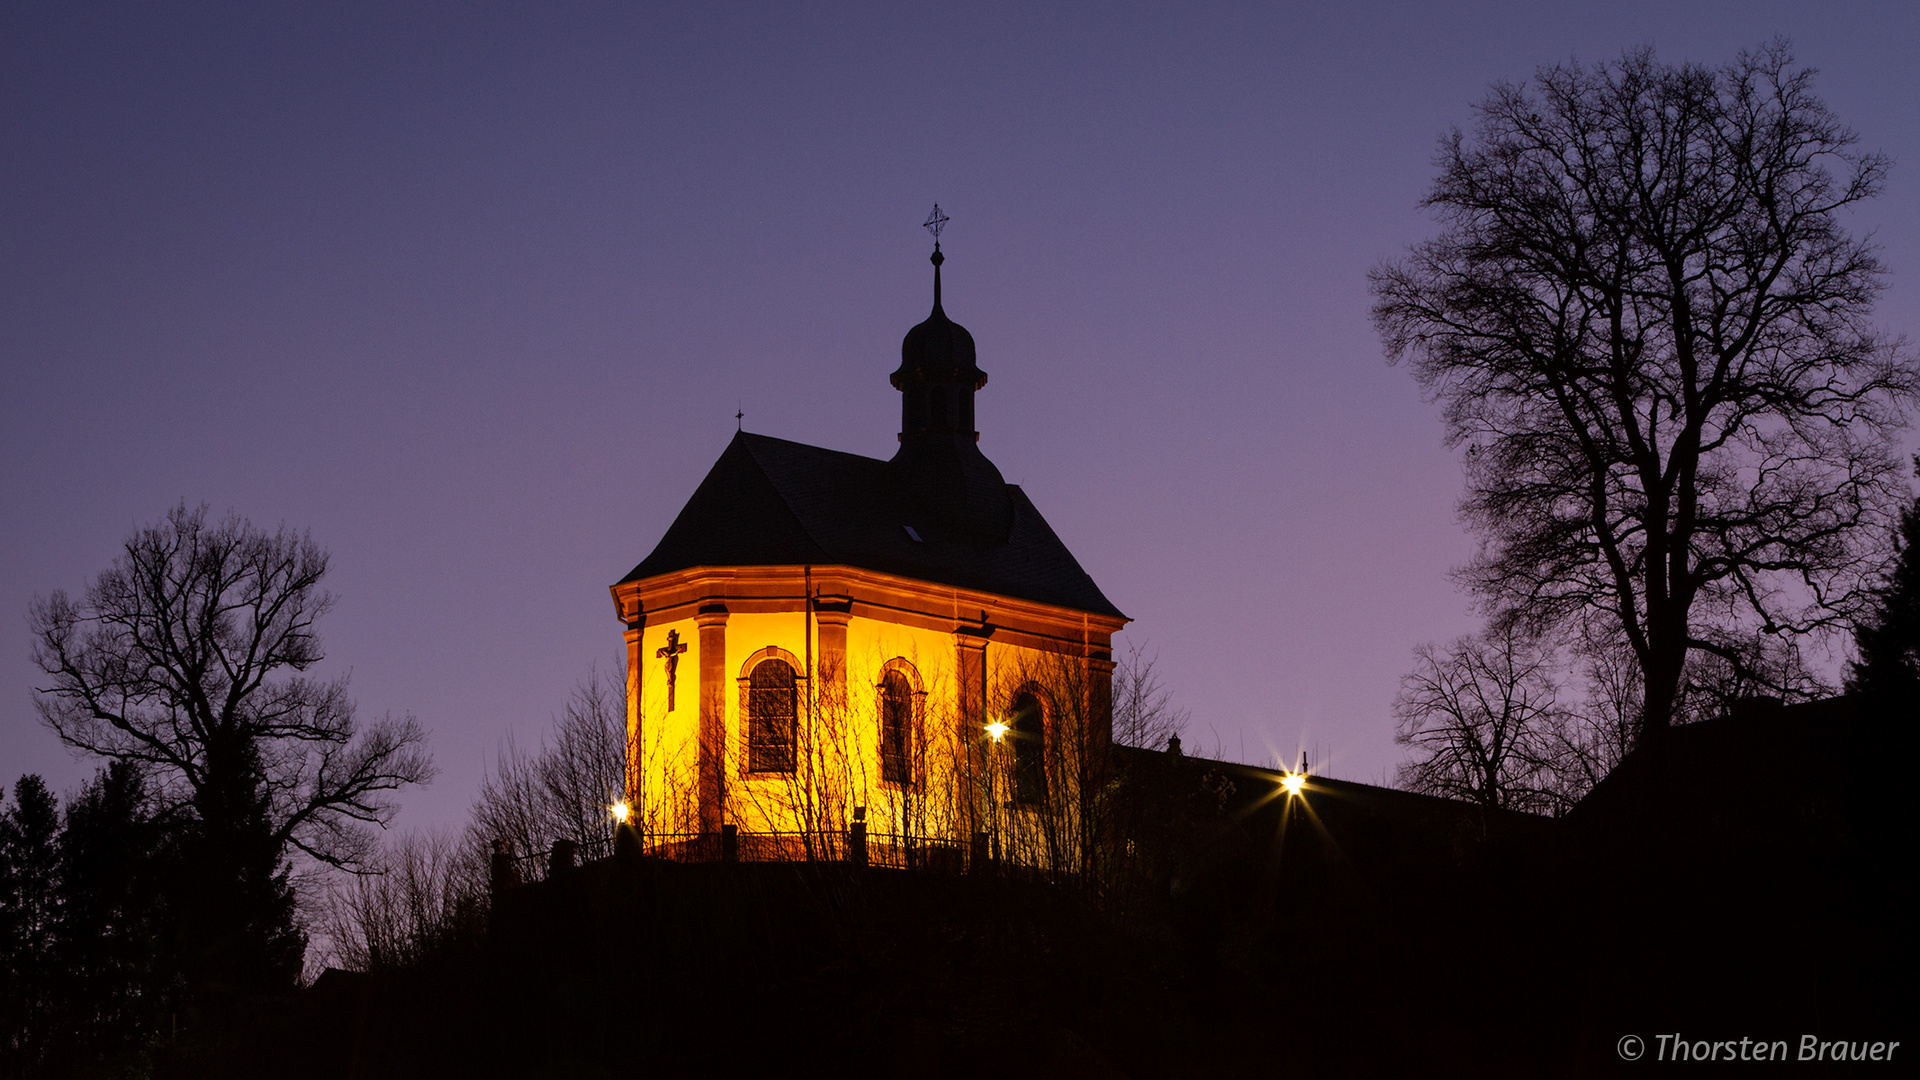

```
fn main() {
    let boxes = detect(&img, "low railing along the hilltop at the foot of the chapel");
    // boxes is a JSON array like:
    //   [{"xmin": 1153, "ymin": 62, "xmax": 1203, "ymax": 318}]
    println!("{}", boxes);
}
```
[{"xmin": 493, "ymin": 826, "xmax": 987, "ymax": 886}]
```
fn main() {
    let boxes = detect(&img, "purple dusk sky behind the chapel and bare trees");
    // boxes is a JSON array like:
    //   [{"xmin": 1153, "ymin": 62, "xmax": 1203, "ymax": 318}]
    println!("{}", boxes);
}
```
[{"xmin": 0, "ymin": 0, "xmax": 1920, "ymax": 824}]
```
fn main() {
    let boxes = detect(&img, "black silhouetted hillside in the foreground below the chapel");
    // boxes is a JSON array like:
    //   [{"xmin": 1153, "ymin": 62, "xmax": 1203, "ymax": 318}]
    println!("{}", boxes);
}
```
[{"xmin": 263, "ymin": 700, "xmax": 1914, "ymax": 1076}]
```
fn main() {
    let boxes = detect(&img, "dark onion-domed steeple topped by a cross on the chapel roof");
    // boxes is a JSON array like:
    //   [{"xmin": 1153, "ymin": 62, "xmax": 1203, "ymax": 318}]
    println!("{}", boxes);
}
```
[{"xmin": 889, "ymin": 206, "xmax": 1012, "ymax": 540}]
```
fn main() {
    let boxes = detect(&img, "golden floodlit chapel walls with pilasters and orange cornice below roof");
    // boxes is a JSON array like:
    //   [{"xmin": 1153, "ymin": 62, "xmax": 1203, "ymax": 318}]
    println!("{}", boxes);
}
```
[{"xmin": 614, "ymin": 567, "xmax": 1123, "ymax": 840}]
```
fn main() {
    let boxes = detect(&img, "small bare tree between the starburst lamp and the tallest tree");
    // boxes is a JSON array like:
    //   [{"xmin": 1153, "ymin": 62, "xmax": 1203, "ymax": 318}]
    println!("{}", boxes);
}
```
[{"xmin": 1394, "ymin": 626, "xmax": 1565, "ymax": 811}]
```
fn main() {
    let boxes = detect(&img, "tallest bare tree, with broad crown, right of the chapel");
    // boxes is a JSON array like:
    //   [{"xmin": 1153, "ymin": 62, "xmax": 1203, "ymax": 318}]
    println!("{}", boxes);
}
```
[{"xmin": 1373, "ymin": 42, "xmax": 1920, "ymax": 740}]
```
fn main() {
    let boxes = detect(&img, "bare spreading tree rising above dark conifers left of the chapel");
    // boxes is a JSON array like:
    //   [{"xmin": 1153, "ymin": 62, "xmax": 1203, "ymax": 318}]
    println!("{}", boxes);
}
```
[{"xmin": 29, "ymin": 503, "xmax": 434, "ymax": 867}]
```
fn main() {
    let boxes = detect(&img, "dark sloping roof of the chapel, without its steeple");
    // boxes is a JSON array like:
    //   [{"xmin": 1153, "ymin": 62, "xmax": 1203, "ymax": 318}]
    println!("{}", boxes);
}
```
[{"xmin": 620, "ymin": 432, "xmax": 1125, "ymax": 619}]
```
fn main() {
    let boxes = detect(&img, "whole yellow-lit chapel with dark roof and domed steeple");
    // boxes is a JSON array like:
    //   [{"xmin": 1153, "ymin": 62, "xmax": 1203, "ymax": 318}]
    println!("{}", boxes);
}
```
[{"xmin": 612, "ymin": 244, "xmax": 1127, "ymax": 859}]
